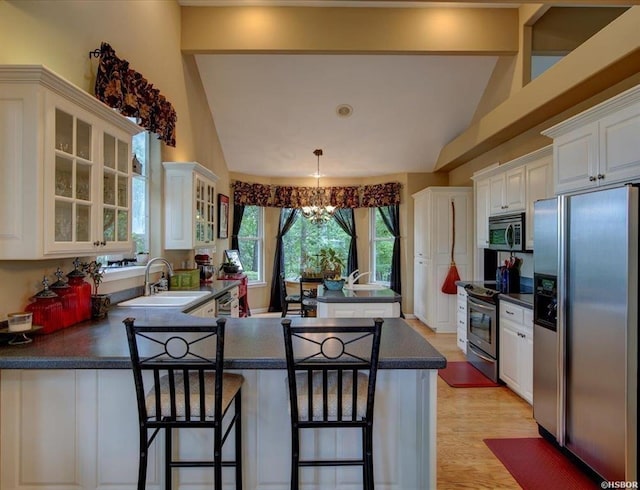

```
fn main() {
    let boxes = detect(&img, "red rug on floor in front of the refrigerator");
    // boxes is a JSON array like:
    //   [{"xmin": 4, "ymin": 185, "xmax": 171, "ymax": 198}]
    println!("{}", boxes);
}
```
[{"xmin": 484, "ymin": 437, "xmax": 600, "ymax": 490}]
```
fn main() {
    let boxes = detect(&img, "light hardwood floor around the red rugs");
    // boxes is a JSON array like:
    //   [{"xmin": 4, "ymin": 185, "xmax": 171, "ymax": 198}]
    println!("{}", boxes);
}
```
[{"xmin": 407, "ymin": 320, "xmax": 538, "ymax": 490}]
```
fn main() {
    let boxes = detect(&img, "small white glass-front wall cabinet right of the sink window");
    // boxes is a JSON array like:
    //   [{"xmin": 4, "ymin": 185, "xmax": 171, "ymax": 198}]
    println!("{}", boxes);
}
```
[{"xmin": 163, "ymin": 162, "xmax": 218, "ymax": 250}]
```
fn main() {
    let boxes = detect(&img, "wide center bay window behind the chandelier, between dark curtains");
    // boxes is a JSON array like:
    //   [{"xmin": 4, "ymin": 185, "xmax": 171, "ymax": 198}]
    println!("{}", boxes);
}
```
[{"xmin": 283, "ymin": 216, "xmax": 350, "ymax": 279}]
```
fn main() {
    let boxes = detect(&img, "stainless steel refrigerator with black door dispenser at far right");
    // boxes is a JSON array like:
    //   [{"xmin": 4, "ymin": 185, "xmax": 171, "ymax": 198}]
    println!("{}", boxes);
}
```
[{"xmin": 534, "ymin": 186, "xmax": 639, "ymax": 481}]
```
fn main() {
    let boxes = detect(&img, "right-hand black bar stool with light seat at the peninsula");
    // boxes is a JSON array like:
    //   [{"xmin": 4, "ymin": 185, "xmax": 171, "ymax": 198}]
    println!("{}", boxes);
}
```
[{"xmin": 282, "ymin": 318, "xmax": 383, "ymax": 490}]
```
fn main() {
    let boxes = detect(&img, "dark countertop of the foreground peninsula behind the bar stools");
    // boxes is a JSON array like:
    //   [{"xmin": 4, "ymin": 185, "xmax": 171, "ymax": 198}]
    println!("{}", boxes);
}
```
[{"xmin": 0, "ymin": 306, "xmax": 447, "ymax": 369}]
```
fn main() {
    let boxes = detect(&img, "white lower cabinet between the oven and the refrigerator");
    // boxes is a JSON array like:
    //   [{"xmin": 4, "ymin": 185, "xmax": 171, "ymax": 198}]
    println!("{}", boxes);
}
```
[{"xmin": 498, "ymin": 300, "xmax": 533, "ymax": 403}]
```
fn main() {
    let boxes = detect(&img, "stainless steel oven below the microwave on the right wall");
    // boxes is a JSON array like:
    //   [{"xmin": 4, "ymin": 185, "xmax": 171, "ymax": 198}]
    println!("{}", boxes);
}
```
[{"xmin": 467, "ymin": 287, "xmax": 498, "ymax": 383}]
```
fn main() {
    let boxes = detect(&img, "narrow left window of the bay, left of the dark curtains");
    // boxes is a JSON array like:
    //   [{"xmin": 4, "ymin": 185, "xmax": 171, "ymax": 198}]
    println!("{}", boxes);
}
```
[{"xmin": 238, "ymin": 206, "xmax": 264, "ymax": 283}]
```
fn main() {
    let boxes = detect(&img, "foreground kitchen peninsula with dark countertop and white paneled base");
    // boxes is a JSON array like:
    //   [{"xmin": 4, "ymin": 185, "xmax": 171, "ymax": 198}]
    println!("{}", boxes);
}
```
[{"xmin": 0, "ymin": 305, "xmax": 446, "ymax": 490}]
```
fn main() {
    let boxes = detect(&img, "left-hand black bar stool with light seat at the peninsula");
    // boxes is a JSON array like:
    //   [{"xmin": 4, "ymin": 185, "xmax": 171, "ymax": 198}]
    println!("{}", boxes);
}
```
[{"xmin": 124, "ymin": 318, "xmax": 244, "ymax": 490}]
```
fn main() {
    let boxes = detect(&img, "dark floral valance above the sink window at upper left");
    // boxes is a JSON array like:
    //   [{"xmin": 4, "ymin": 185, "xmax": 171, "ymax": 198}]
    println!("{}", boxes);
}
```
[{"xmin": 95, "ymin": 43, "xmax": 178, "ymax": 146}]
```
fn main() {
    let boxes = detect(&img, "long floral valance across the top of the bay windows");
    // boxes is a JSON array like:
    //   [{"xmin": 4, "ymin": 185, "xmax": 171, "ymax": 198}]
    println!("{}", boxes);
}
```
[{"xmin": 232, "ymin": 182, "xmax": 402, "ymax": 209}]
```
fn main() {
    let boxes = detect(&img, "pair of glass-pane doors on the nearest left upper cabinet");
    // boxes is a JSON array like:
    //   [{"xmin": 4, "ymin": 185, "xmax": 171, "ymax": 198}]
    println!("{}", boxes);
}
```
[{"xmin": 45, "ymin": 101, "xmax": 132, "ymax": 254}]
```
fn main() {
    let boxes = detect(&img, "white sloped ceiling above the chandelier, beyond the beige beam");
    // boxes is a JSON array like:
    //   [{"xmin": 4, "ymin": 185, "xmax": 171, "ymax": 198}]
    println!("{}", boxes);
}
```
[{"xmin": 196, "ymin": 54, "xmax": 497, "ymax": 177}]
